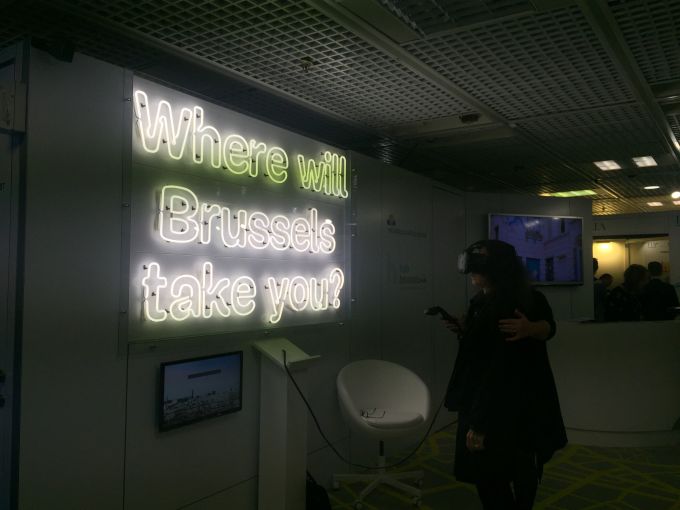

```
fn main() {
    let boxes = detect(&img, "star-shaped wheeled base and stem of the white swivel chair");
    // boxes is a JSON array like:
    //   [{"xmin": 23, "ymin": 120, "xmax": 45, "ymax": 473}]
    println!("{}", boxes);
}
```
[{"xmin": 333, "ymin": 441, "xmax": 425, "ymax": 510}]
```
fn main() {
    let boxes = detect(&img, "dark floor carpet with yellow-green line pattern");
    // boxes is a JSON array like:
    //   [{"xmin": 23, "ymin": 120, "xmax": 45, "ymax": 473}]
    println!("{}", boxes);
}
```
[{"xmin": 330, "ymin": 428, "xmax": 680, "ymax": 510}]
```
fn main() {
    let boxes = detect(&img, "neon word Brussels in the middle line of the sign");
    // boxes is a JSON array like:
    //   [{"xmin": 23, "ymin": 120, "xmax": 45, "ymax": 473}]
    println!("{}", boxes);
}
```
[{"xmin": 158, "ymin": 186, "xmax": 336, "ymax": 254}]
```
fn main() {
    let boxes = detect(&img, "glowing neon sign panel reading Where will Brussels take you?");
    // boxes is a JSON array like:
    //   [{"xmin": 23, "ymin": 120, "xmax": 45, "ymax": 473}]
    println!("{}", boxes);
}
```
[{"xmin": 129, "ymin": 79, "xmax": 349, "ymax": 341}]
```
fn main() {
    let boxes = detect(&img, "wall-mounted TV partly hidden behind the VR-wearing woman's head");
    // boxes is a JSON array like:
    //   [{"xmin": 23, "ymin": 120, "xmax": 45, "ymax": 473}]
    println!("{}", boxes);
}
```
[{"xmin": 489, "ymin": 214, "xmax": 583, "ymax": 285}]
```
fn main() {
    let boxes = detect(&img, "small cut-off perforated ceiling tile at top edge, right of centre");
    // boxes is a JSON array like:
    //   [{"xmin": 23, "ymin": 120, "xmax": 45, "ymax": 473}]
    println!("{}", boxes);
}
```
[{"xmin": 380, "ymin": 0, "xmax": 534, "ymax": 35}]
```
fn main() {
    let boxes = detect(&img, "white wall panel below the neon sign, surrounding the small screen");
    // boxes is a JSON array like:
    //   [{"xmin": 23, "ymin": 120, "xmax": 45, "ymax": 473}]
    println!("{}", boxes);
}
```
[{"xmin": 125, "ymin": 337, "xmax": 260, "ymax": 510}]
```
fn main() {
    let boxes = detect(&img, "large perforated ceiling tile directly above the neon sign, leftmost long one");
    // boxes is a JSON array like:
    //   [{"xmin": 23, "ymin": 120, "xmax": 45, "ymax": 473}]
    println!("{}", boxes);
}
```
[{"xmin": 54, "ymin": 0, "xmax": 471, "ymax": 126}]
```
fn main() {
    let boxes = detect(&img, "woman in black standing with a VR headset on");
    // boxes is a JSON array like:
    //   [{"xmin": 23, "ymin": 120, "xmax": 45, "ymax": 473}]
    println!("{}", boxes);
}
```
[{"xmin": 446, "ymin": 241, "xmax": 567, "ymax": 510}]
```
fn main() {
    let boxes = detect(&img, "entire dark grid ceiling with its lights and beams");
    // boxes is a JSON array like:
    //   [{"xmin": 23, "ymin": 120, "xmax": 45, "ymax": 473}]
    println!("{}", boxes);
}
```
[{"xmin": 0, "ymin": 0, "xmax": 680, "ymax": 214}]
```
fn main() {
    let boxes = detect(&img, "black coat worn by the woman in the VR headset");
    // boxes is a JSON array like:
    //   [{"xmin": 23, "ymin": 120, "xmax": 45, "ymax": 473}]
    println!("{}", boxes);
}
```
[{"xmin": 445, "ymin": 290, "xmax": 567, "ymax": 483}]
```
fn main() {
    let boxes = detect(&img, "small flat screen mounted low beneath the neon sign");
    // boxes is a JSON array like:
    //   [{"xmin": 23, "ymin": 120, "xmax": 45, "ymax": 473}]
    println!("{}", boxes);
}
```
[{"xmin": 159, "ymin": 351, "xmax": 243, "ymax": 431}]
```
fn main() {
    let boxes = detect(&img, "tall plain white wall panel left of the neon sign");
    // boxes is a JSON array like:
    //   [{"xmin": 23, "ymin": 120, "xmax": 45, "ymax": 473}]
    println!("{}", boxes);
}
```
[{"xmin": 19, "ymin": 51, "xmax": 126, "ymax": 510}]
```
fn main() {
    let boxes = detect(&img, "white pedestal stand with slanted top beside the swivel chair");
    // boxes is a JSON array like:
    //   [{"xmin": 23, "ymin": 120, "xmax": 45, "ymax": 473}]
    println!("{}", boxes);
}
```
[{"xmin": 254, "ymin": 338, "xmax": 320, "ymax": 510}]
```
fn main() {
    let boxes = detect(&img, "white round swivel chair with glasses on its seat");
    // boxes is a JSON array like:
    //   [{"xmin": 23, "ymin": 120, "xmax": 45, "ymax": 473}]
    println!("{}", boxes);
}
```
[{"xmin": 333, "ymin": 360, "xmax": 431, "ymax": 509}]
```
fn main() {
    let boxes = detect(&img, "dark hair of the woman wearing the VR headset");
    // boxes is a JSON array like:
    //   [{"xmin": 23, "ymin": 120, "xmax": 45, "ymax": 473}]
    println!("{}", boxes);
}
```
[{"xmin": 475, "ymin": 240, "xmax": 529, "ymax": 304}]
